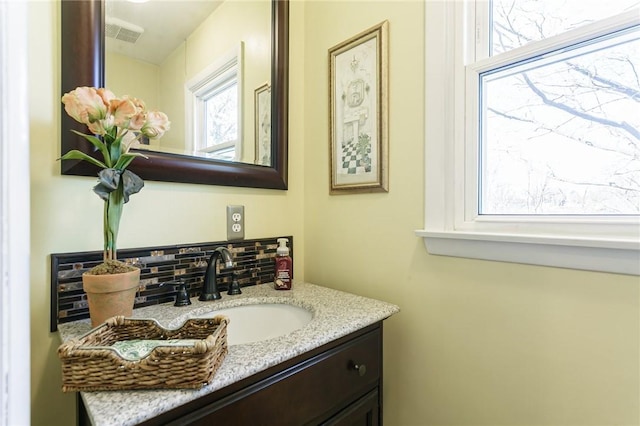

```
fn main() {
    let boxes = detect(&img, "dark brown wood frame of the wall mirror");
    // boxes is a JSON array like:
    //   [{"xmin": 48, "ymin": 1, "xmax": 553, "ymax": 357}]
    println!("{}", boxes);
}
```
[{"xmin": 61, "ymin": 0, "xmax": 289, "ymax": 189}]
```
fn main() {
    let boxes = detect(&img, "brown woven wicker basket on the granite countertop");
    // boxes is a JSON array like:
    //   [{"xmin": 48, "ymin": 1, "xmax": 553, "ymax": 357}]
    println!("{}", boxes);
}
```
[{"xmin": 58, "ymin": 316, "xmax": 229, "ymax": 392}]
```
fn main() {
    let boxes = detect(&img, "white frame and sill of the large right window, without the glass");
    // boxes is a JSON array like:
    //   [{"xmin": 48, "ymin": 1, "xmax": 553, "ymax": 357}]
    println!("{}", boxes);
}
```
[{"xmin": 416, "ymin": 1, "xmax": 640, "ymax": 275}]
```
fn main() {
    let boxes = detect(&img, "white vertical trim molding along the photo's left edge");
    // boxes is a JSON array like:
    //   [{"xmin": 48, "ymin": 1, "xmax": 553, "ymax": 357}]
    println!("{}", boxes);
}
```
[{"xmin": 0, "ymin": 0, "xmax": 31, "ymax": 426}]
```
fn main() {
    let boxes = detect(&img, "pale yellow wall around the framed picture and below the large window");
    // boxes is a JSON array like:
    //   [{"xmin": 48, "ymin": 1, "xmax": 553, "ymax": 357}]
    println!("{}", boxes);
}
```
[{"xmin": 304, "ymin": 1, "xmax": 640, "ymax": 426}]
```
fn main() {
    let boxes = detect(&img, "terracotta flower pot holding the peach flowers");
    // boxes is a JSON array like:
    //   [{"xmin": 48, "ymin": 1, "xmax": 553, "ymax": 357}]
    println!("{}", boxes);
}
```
[{"xmin": 82, "ymin": 269, "xmax": 140, "ymax": 327}]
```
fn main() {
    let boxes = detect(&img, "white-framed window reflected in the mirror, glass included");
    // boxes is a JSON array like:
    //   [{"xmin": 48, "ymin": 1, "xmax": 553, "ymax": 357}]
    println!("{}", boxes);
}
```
[{"xmin": 186, "ymin": 43, "xmax": 243, "ymax": 161}]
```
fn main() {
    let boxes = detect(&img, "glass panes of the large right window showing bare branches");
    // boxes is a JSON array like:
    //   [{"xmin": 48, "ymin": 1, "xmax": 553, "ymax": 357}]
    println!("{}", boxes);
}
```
[{"xmin": 480, "ymin": 0, "xmax": 640, "ymax": 215}]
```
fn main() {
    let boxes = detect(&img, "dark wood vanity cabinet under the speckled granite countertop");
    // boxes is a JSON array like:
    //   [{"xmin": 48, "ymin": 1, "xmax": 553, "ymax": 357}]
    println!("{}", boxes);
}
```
[{"xmin": 79, "ymin": 322, "xmax": 382, "ymax": 426}]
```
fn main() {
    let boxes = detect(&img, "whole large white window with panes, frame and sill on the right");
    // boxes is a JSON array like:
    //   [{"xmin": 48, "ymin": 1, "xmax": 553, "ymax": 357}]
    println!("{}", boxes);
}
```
[{"xmin": 418, "ymin": 0, "xmax": 640, "ymax": 274}]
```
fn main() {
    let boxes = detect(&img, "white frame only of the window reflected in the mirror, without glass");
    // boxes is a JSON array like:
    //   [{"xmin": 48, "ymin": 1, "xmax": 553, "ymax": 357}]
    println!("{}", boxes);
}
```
[{"xmin": 185, "ymin": 42, "xmax": 244, "ymax": 161}]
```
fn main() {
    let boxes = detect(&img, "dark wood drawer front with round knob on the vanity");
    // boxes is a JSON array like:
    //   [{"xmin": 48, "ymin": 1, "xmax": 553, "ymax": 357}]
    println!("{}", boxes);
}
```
[{"xmin": 182, "ymin": 329, "xmax": 382, "ymax": 426}]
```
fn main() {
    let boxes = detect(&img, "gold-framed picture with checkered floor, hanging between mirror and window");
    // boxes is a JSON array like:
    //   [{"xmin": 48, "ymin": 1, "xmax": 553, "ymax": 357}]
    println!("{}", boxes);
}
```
[{"xmin": 329, "ymin": 21, "xmax": 389, "ymax": 194}]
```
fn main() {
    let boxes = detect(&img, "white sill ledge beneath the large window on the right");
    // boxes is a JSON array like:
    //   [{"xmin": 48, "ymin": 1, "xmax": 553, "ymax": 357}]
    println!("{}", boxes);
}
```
[{"xmin": 416, "ymin": 230, "xmax": 640, "ymax": 275}]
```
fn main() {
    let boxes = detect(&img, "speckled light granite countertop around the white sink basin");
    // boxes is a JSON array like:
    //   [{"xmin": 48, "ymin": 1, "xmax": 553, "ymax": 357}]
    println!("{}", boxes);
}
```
[{"xmin": 58, "ymin": 283, "xmax": 400, "ymax": 426}]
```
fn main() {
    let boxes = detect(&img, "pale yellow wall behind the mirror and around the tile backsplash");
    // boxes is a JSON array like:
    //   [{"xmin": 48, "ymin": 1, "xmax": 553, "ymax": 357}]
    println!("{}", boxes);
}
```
[{"xmin": 31, "ymin": 0, "xmax": 304, "ymax": 426}]
